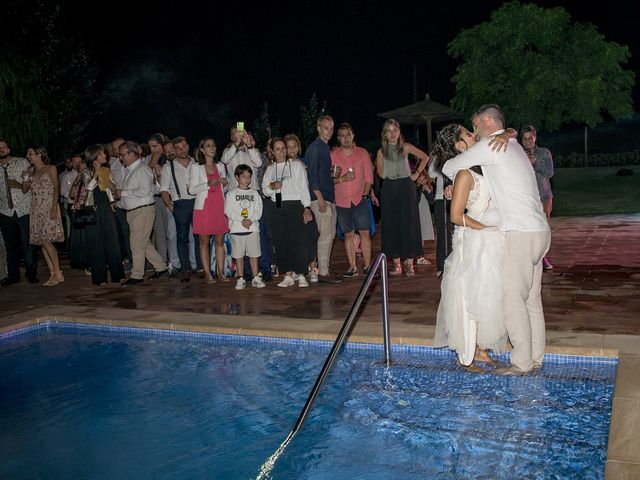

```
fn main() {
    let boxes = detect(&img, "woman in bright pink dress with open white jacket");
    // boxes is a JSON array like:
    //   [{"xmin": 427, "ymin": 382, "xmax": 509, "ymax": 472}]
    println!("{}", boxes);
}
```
[{"xmin": 187, "ymin": 137, "xmax": 229, "ymax": 283}]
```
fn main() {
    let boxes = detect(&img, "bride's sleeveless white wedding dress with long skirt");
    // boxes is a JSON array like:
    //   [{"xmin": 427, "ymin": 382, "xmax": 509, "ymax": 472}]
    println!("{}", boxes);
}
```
[{"xmin": 434, "ymin": 170, "xmax": 507, "ymax": 365}]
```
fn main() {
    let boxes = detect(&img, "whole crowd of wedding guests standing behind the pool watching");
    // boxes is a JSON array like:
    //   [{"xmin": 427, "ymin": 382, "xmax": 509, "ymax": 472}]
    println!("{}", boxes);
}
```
[{"xmin": 0, "ymin": 115, "xmax": 553, "ymax": 289}]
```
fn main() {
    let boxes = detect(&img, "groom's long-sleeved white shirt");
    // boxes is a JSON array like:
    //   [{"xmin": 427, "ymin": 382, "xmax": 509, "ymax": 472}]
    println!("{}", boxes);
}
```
[{"xmin": 442, "ymin": 130, "xmax": 549, "ymax": 232}]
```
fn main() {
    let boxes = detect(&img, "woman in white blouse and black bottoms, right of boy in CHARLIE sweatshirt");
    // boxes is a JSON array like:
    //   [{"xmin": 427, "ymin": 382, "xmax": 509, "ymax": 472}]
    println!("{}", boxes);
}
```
[{"xmin": 262, "ymin": 138, "xmax": 318, "ymax": 287}]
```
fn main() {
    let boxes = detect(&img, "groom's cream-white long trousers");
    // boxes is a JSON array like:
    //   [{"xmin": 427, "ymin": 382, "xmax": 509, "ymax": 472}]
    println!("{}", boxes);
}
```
[{"xmin": 503, "ymin": 231, "xmax": 551, "ymax": 372}]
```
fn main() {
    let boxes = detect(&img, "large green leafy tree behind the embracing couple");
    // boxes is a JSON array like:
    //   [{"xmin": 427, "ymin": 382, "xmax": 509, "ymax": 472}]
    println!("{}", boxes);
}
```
[{"xmin": 448, "ymin": 1, "xmax": 635, "ymax": 131}]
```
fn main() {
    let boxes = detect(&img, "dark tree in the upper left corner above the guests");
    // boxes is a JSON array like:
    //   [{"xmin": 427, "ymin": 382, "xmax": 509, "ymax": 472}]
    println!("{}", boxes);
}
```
[{"xmin": 0, "ymin": 0, "xmax": 97, "ymax": 158}]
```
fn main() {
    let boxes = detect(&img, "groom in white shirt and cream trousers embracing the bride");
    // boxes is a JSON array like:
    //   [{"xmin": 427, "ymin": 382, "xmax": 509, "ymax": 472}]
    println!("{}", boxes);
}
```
[{"xmin": 442, "ymin": 105, "xmax": 551, "ymax": 375}]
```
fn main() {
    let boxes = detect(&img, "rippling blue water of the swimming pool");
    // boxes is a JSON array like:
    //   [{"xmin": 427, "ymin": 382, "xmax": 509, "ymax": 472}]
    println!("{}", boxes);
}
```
[{"xmin": 0, "ymin": 323, "xmax": 617, "ymax": 480}]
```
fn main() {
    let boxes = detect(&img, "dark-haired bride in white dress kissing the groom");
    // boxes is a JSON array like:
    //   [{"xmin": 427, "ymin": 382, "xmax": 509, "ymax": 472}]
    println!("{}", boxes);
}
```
[{"xmin": 432, "ymin": 124, "xmax": 507, "ymax": 371}]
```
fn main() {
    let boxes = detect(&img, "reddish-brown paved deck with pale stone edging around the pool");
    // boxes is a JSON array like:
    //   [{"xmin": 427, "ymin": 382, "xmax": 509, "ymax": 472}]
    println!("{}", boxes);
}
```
[{"xmin": 0, "ymin": 214, "xmax": 640, "ymax": 479}]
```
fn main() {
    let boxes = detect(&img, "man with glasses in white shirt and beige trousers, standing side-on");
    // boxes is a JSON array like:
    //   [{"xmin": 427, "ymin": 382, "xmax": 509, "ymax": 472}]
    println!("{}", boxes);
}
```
[{"xmin": 119, "ymin": 141, "xmax": 168, "ymax": 287}]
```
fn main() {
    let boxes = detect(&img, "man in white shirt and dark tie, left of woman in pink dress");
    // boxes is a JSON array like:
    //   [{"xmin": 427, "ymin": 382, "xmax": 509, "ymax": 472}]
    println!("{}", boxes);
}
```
[{"xmin": 160, "ymin": 137, "xmax": 200, "ymax": 282}]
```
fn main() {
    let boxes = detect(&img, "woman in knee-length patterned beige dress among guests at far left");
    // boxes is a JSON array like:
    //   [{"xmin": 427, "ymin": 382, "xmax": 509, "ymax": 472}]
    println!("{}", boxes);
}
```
[{"xmin": 22, "ymin": 147, "xmax": 64, "ymax": 287}]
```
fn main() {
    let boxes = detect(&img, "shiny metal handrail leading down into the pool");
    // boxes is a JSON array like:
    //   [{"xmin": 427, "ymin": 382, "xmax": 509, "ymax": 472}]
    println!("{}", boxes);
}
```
[{"xmin": 257, "ymin": 253, "xmax": 391, "ymax": 479}]
